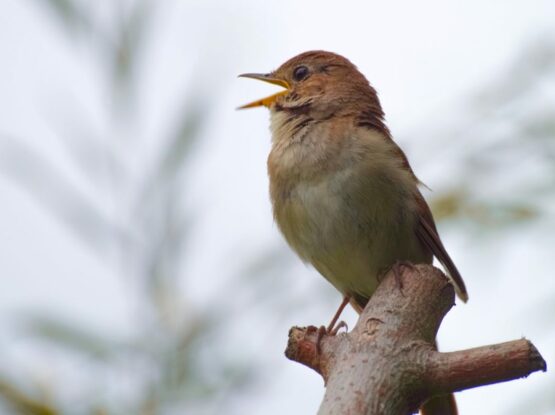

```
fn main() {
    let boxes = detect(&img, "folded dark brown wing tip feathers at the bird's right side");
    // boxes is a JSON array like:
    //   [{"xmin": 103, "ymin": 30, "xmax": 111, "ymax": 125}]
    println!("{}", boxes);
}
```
[{"xmin": 416, "ymin": 192, "xmax": 468, "ymax": 303}]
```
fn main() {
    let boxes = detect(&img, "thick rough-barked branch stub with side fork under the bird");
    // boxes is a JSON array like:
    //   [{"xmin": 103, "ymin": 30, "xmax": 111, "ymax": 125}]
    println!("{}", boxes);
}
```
[{"xmin": 285, "ymin": 265, "xmax": 546, "ymax": 415}]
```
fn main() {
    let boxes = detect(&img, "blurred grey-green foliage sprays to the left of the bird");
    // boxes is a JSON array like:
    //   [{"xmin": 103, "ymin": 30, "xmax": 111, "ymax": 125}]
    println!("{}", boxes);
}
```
[{"xmin": 0, "ymin": 0, "xmax": 250, "ymax": 415}]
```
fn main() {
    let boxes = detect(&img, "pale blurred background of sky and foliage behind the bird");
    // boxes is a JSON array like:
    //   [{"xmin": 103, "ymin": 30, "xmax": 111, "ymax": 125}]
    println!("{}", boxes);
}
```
[{"xmin": 0, "ymin": 0, "xmax": 555, "ymax": 415}]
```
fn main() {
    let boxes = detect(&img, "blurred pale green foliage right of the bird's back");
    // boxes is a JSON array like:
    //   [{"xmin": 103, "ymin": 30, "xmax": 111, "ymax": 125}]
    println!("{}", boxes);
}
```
[{"xmin": 432, "ymin": 40, "xmax": 555, "ymax": 229}]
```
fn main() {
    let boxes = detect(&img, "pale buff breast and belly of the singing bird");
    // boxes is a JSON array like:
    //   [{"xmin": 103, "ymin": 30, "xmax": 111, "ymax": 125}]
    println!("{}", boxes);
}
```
[{"xmin": 270, "ymin": 125, "xmax": 424, "ymax": 298}]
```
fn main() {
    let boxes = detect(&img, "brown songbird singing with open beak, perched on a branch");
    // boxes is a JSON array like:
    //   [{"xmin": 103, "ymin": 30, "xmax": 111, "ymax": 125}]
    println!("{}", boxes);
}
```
[{"xmin": 240, "ymin": 51, "xmax": 468, "ymax": 414}]
